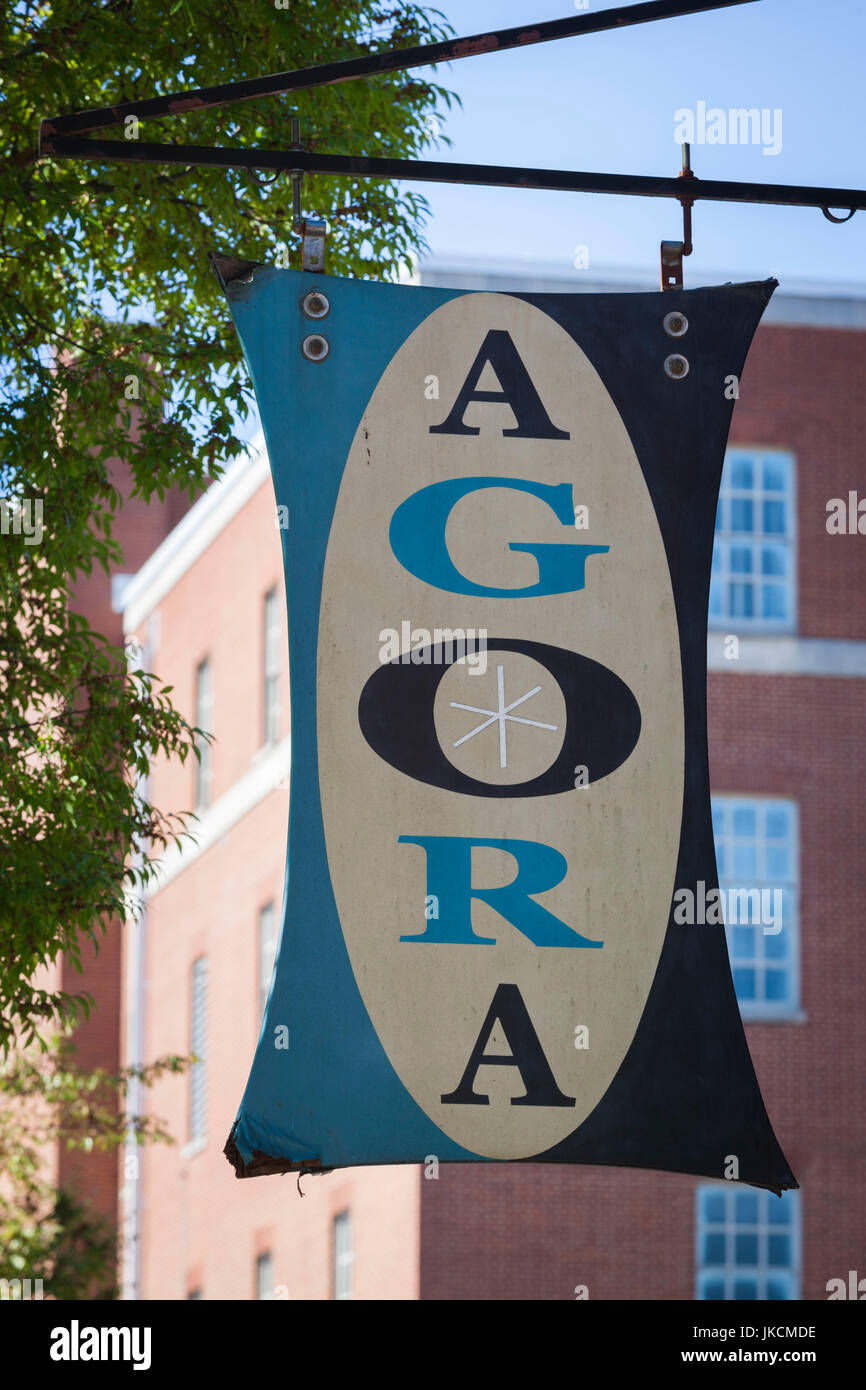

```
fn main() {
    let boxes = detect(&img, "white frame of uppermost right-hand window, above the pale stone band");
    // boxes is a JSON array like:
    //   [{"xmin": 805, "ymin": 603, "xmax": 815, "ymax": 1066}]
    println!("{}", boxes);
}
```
[{"xmin": 709, "ymin": 445, "xmax": 798, "ymax": 634}]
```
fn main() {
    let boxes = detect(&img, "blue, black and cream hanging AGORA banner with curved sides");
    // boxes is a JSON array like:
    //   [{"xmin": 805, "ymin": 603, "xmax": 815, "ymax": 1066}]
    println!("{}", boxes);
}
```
[{"xmin": 214, "ymin": 257, "xmax": 796, "ymax": 1190}]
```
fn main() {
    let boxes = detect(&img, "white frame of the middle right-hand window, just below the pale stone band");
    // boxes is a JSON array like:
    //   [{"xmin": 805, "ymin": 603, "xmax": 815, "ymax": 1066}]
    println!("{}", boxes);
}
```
[{"xmin": 712, "ymin": 792, "xmax": 801, "ymax": 1022}]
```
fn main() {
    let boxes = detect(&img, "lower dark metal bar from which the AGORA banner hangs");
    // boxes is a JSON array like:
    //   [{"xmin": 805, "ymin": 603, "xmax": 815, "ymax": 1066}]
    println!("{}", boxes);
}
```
[{"xmin": 44, "ymin": 136, "xmax": 866, "ymax": 211}]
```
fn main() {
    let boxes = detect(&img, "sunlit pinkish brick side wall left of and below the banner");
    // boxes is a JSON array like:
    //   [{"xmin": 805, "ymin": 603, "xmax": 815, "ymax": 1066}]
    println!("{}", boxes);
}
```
[{"xmin": 131, "ymin": 482, "xmax": 420, "ymax": 1300}]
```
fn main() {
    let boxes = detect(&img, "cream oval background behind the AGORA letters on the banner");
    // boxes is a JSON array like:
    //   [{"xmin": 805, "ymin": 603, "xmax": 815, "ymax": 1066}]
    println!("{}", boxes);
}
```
[{"xmin": 317, "ymin": 293, "xmax": 684, "ymax": 1159}]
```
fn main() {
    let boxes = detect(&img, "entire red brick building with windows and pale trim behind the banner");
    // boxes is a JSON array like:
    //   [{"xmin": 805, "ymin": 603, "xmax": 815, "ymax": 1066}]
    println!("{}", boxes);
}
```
[{"xmin": 109, "ymin": 267, "xmax": 866, "ymax": 1300}]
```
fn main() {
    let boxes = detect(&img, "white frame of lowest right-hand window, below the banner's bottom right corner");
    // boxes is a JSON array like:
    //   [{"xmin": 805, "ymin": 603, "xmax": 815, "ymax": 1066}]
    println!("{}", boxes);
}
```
[{"xmin": 695, "ymin": 1182, "xmax": 802, "ymax": 1302}]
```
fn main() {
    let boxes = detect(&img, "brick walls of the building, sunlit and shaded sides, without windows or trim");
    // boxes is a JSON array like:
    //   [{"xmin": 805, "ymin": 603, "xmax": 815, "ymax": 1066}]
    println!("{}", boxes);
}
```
[{"xmin": 128, "ymin": 319, "xmax": 866, "ymax": 1300}]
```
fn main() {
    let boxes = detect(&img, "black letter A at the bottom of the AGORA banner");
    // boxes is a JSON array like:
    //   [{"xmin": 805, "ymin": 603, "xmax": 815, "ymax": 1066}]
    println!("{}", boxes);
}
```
[{"xmin": 442, "ymin": 984, "xmax": 575, "ymax": 1108}]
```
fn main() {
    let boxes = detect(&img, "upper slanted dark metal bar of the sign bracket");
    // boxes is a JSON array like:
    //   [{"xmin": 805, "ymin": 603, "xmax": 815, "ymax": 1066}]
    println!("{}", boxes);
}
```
[{"xmin": 39, "ymin": 0, "xmax": 755, "ymax": 141}]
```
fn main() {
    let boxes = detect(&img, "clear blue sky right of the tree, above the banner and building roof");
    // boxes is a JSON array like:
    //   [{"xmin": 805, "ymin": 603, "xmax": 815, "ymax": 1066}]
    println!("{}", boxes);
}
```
[{"xmin": 405, "ymin": 0, "xmax": 866, "ymax": 289}]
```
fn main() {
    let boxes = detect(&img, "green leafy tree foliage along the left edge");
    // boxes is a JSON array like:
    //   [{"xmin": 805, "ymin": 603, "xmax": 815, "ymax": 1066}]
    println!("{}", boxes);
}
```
[{"xmin": 0, "ymin": 0, "xmax": 452, "ymax": 1051}]
